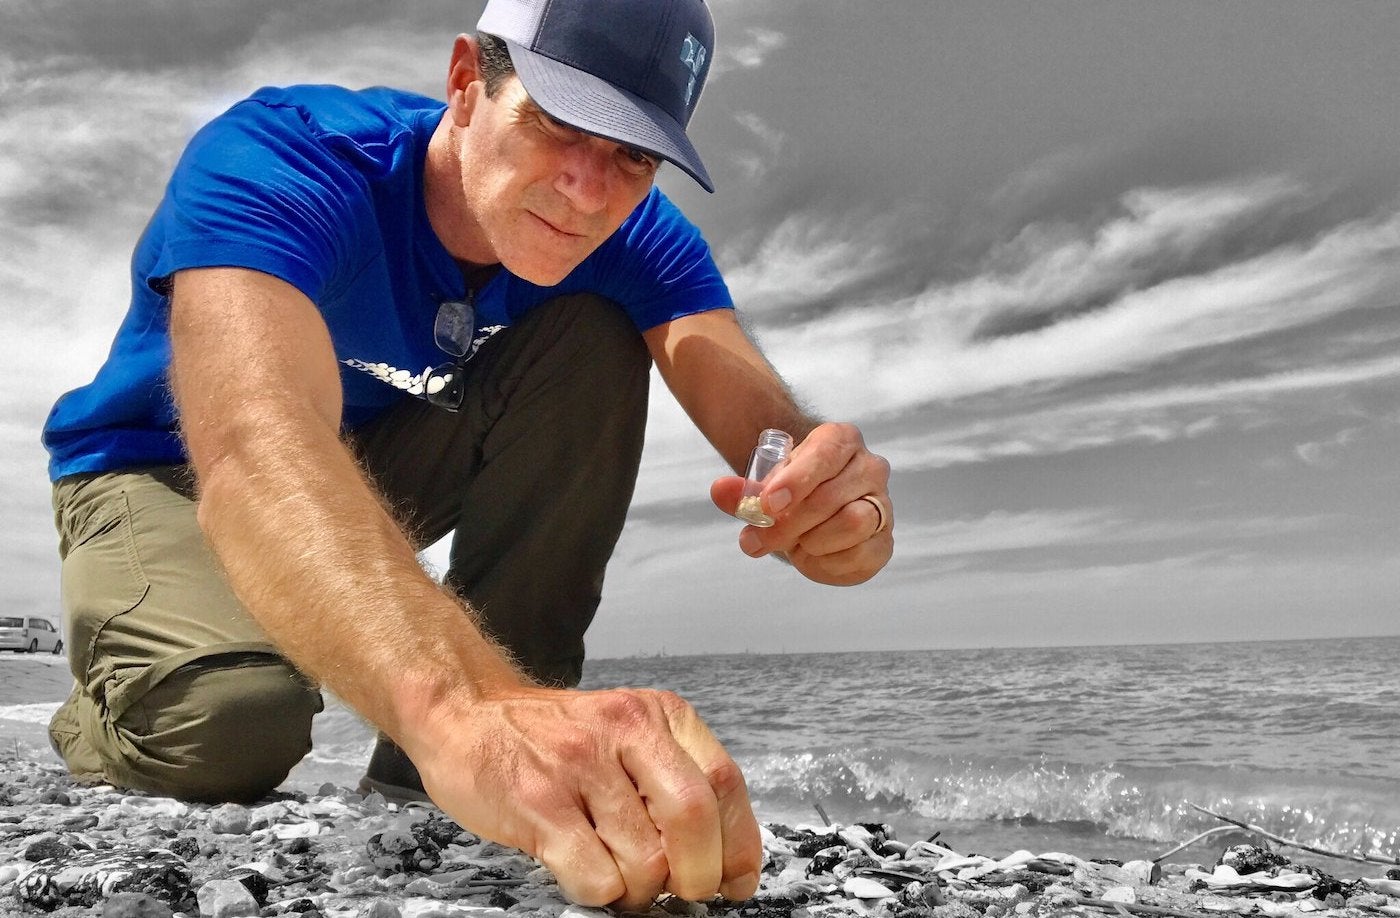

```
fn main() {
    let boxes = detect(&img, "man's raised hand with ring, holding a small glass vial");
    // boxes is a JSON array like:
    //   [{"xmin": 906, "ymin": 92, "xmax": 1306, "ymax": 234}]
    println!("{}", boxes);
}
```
[{"xmin": 710, "ymin": 424, "xmax": 895, "ymax": 586}]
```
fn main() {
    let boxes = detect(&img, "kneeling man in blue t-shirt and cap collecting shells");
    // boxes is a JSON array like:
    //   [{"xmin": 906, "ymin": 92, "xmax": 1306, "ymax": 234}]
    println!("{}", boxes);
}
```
[{"xmin": 45, "ymin": 0, "xmax": 893, "ymax": 907}]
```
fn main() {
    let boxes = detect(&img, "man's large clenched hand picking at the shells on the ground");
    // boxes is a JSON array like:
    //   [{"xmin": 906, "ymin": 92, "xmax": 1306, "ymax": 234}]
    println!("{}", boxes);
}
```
[{"xmin": 405, "ymin": 689, "xmax": 763, "ymax": 911}]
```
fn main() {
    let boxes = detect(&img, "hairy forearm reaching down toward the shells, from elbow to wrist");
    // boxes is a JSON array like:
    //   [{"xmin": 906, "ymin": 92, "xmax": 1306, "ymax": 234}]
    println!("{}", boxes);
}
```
[{"xmin": 191, "ymin": 405, "xmax": 521, "ymax": 749}]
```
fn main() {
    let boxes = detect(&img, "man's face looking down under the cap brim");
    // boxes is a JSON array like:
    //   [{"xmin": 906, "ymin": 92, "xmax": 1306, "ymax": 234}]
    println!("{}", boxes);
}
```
[{"xmin": 458, "ymin": 77, "xmax": 658, "ymax": 287}]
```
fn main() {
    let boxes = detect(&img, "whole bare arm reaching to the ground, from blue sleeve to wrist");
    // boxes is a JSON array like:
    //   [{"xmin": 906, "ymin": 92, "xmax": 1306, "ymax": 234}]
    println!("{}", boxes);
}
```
[{"xmin": 171, "ymin": 269, "xmax": 521, "ymax": 754}]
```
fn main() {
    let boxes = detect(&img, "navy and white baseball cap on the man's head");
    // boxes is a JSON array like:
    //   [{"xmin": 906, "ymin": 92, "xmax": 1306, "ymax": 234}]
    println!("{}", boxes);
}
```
[{"xmin": 476, "ymin": 0, "xmax": 714, "ymax": 192}]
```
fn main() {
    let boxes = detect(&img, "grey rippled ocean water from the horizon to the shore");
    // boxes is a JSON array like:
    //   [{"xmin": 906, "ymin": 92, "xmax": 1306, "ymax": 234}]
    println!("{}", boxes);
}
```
[{"xmin": 0, "ymin": 637, "xmax": 1400, "ymax": 876}]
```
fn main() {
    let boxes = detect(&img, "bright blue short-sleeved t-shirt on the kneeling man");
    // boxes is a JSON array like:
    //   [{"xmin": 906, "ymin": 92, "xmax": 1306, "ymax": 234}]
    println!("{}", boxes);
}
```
[{"xmin": 43, "ymin": 85, "xmax": 732, "ymax": 480}]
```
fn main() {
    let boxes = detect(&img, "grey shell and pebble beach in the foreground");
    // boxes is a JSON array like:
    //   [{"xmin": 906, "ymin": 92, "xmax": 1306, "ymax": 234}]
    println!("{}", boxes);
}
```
[{"xmin": 0, "ymin": 738, "xmax": 1400, "ymax": 918}]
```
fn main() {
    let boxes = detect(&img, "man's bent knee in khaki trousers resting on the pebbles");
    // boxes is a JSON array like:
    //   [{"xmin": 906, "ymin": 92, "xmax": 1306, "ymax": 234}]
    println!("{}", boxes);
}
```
[{"xmin": 99, "ymin": 659, "xmax": 322, "ymax": 802}]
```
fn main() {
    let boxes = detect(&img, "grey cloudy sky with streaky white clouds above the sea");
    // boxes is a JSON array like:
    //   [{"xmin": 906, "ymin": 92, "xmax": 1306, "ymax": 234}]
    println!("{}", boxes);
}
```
[{"xmin": 0, "ymin": 0, "xmax": 1400, "ymax": 656}]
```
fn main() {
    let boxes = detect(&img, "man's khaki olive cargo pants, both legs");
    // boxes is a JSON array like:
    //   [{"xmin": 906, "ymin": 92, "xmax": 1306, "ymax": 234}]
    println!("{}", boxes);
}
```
[{"xmin": 49, "ymin": 295, "xmax": 651, "ymax": 800}]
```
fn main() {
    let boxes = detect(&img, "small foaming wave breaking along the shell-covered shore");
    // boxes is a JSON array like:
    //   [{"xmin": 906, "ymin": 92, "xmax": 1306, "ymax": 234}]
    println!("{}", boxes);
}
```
[{"xmin": 741, "ymin": 749, "xmax": 1400, "ymax": 858}]
